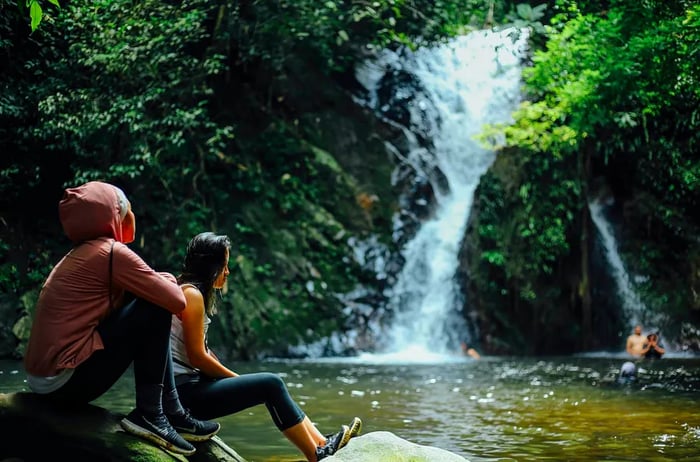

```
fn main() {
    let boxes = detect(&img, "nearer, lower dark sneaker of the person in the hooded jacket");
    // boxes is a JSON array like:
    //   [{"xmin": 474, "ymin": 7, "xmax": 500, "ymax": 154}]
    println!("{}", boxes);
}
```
[{"xmin": 120, "ymin": 409, "xmax": 195, "ymax": 456}]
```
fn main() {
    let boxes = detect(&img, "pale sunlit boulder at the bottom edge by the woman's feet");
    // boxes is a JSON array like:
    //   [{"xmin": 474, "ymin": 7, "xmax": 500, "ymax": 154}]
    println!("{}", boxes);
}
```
[{"xmin": 330, "ymin": 431, "xmax": 469, "ymax": 462}]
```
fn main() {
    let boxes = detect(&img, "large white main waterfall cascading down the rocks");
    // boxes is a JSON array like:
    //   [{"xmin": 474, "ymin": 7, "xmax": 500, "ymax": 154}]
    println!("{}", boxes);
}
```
[{"xmin": 357, "ymin": 29, "xmax": 528, "ymax": 360}]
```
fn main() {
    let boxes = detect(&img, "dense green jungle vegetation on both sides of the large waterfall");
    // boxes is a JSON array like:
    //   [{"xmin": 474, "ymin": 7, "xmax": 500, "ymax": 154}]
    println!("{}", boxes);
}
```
[{"xmin": 0, "ymin": 0, "xmax": 700, "ymax": 358}]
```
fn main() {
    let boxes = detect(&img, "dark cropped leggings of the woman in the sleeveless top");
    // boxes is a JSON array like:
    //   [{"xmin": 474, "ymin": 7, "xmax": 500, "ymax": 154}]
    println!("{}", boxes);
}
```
[{"xmin": 177, "ymin": 372, "xmax": 305, "ymax": 431}]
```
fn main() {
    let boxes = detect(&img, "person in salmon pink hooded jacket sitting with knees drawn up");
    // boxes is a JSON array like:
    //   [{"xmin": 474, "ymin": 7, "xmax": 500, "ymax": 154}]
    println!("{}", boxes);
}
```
[{"xmin": 24, "ymin": 181, "xmax": 220, "ymax": 455}]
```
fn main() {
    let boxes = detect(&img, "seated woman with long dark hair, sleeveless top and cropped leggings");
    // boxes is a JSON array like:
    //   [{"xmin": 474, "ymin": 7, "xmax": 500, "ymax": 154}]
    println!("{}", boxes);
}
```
[{"xmin": 170, "ymin": 232, "xmax": 362, "ymax": 462}]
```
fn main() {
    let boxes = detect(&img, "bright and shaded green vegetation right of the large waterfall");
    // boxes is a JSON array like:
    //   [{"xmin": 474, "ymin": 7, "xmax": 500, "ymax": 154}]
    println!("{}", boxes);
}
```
[{"xmin": 472, "ymin": 1, "xmax": 700, "ymax": 352}]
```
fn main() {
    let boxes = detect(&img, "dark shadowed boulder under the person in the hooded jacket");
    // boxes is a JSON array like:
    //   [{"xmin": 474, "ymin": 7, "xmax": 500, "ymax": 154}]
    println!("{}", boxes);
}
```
[{"xmin": 0, "ymin": 392, "xmax": 245, "ymax": 462}]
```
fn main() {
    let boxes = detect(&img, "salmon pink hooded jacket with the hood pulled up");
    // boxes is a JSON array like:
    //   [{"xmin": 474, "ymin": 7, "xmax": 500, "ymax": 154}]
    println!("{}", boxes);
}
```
[{"xmin": 24, "ymin": 181, "xmax": 186, "ymax": 377}]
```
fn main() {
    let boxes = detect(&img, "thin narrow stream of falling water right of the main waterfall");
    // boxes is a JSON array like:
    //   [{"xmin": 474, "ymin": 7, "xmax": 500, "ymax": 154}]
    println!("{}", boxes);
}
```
[{"xmin": 588, "ymin": 199, "xmax": 648, "ymax": 331}]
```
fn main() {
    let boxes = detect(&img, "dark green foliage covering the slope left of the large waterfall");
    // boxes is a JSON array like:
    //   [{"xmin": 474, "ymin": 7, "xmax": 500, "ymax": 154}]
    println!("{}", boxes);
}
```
[{"xmin": 0, "ymin": 0, "xmax": 516, "ymax": 356}]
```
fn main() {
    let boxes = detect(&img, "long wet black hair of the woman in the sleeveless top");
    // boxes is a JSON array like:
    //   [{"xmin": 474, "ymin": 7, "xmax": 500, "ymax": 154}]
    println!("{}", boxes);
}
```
[{"xmin": 177, "ymin": 231, "xmax": 231, "ymax": 315}]
